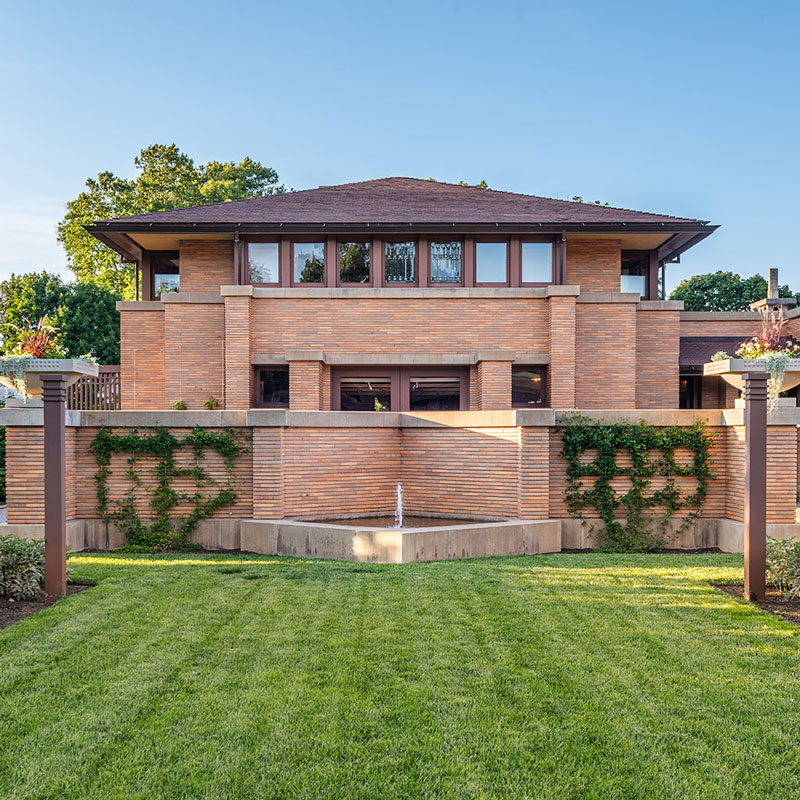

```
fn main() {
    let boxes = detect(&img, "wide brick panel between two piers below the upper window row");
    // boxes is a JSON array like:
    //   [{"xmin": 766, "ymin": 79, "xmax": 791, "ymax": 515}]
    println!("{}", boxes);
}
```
[{"xmin": 251, "ymin": 297, "xmax": 550, "ymax": 353}]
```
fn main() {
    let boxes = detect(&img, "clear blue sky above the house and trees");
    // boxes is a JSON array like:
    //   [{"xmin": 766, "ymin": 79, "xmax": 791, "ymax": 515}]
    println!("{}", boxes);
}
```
[{"xmin": 0, "ymin": 0, "xmax": 800, "ymax": 290}]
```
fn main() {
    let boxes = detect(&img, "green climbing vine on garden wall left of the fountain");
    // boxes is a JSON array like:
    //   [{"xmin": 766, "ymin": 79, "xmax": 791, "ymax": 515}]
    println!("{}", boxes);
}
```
[{"xmin": 91, "ymin": 427, "xmax": 248, "ymax": 550}]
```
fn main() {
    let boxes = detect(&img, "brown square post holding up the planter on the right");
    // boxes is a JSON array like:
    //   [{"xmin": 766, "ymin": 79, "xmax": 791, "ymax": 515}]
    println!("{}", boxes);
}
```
[{"xmin": 742, "ymin": 372, "xmax": 769, "ymax": 601}]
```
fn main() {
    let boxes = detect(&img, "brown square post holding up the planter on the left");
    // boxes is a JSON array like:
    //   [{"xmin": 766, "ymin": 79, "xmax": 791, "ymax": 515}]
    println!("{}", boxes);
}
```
[{"xmin": 41, "ymin": 375, "xmax": 67, "ymax": 602}]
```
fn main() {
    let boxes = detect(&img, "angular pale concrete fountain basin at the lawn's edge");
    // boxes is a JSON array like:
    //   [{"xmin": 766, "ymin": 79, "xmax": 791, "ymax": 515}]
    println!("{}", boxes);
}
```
[{"xmin": 241, "ymin": 516, "xmax": 561, "ymax": 564}]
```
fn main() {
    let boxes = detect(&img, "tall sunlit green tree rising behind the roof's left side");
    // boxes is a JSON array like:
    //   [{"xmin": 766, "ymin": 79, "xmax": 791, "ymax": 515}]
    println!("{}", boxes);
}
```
[{"xmin": 58, "ymin": 144, "xmax": 286, "ymax": 299}]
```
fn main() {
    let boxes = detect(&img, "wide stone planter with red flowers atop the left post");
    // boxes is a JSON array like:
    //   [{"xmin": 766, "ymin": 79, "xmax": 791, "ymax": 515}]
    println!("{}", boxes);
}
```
[{"xmin": 0, "ymin": 316, "xmax": 99, "ymax": 398}]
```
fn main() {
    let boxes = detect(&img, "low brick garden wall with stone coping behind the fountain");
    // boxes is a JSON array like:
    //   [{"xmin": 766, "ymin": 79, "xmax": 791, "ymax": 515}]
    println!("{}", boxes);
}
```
[{"xmin": 0, "ymin": 408, "xmax": 800, "ymax": 549}]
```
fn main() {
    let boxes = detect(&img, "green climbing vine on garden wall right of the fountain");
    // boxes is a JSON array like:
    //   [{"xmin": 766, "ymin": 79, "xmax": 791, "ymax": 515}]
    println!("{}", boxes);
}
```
[{"xmin": 561, "ymin": 414, "xmax": 715, "ymax": 551}]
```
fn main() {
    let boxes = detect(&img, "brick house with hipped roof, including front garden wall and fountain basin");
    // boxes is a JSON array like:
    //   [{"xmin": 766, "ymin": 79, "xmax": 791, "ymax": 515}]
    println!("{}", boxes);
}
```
[{"xmin": 3, "ymin": 178, "xmax": 800, "ymax": 561}]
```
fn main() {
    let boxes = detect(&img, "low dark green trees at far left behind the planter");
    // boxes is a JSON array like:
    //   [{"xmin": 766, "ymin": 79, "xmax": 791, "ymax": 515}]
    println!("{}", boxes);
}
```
[{"xmin": 0, "ymin": 272, "xmax": 119, "ymax": 364}]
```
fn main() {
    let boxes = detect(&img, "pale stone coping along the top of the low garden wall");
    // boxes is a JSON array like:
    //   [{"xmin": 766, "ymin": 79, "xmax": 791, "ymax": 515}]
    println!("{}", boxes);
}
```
[{"xmin": 0, "ymin": 407, "xmax": 800, "ymax": 428}]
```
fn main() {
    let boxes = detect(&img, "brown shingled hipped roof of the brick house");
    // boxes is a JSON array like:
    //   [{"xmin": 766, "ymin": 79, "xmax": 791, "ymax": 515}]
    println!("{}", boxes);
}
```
[{"xmin": 98, "ymin": 178, "xmax": 704, "ymax": 225}]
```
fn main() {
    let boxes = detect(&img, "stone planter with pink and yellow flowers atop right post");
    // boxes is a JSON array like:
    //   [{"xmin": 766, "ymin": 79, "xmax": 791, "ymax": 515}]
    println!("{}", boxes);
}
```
[{"xmin": 703, "ymin": 306, "xmax": 800, "ymax": 405}]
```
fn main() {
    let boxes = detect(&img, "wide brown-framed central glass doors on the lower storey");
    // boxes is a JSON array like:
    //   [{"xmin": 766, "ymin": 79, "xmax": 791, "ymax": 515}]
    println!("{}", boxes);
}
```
[{"xmin": 331, "ymin": 367, "xmax": 469, "ymax": 411}]
